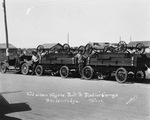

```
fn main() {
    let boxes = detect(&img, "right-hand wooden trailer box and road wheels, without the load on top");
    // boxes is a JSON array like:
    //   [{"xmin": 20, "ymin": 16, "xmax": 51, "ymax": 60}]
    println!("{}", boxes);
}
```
[{"xmin": 82, "ymin": 53, "xmax": 150, "ymax": 83}]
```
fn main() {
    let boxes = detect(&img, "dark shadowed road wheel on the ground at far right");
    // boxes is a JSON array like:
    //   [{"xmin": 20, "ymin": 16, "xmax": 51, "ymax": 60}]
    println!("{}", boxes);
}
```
[{"xmin": 135, "ymin": 70, "xmax": 146, "ymax": 82}]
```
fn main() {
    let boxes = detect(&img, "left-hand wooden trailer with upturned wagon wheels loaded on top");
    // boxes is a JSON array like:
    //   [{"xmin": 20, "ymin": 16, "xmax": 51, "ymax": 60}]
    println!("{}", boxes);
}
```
[{"xmin": 35, "ymin": 44, "xmax": 85, "ymax": 78}]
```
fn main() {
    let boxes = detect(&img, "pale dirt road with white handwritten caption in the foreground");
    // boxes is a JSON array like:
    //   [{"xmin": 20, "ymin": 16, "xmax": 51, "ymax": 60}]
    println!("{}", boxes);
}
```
[{"xmin": 0, "ymin": 73, "xmax": 150, "ymax": 120}]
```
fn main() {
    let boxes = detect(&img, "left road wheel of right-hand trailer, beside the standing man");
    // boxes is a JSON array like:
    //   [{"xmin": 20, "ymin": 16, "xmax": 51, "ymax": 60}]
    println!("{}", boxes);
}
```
[{"xmin": 82, "ymin": 66, "xmax": 94, "ymax": 80}]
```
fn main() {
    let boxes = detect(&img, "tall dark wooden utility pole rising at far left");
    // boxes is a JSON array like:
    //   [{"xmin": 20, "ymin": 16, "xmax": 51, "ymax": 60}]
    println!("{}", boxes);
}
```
[{"xmin": 3, "ymin": 0, "xmax": 9, "ymax": 61}]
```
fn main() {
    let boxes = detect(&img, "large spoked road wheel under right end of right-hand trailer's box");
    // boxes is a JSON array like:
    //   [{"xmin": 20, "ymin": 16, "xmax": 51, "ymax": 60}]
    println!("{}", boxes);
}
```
[{"xmin": 115, "ymin": 67, "xmax": 128, "ymax": 83}]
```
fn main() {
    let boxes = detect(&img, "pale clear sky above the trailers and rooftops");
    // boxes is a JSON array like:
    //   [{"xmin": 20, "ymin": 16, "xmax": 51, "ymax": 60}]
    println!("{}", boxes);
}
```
[{"xmin": 0, "ymin": 0, "xmax": 150, "ymax": 48}]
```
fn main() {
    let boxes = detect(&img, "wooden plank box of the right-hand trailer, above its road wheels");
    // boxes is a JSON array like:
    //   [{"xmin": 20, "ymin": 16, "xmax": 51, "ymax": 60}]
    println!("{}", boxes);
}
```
[{"xmin": 87, "ymin": 53, "xmax": 144, "ymax": 67}]
